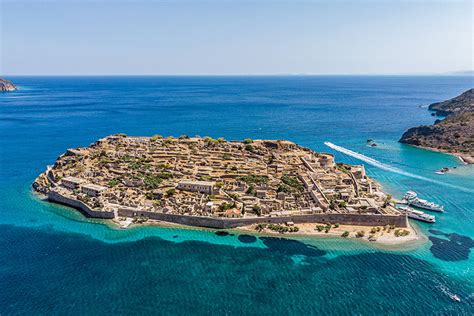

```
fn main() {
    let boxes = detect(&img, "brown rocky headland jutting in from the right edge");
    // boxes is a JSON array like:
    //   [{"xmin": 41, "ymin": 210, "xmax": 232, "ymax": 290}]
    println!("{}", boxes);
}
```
[{"xmin": 400, "ymin": 89, "xmax": 474, "ymax": 163}]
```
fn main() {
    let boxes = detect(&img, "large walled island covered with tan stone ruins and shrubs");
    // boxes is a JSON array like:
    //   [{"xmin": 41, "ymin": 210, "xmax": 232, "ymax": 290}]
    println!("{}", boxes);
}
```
[{"xmin": 33, "ymin": 134, "xmax": 408, "ymax": 238}]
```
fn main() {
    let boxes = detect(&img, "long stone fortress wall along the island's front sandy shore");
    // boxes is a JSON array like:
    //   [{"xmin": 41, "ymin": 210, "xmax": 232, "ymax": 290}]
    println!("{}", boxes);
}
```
[{"xmin": 118, "ymin": 209, "xmax": 408, "ymax": 229}]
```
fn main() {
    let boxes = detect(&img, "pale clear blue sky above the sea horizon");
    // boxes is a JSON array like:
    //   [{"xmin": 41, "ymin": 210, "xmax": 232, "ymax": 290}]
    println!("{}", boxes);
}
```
[{"xmin": 0, "ymin": 0, "xmax": 473, "ymax": 75}]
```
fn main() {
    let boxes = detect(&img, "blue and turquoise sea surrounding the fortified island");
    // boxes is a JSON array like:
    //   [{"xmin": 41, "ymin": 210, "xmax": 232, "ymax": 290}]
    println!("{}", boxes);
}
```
[{"xmin": 0, "ymin": 76, "xmax": 474, "ymax": 315}]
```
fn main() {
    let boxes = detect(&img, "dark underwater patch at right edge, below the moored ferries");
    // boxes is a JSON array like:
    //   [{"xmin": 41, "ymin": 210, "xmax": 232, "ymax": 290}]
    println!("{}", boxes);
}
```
[{"xmin": 429, "ymin": 229, "xmax": 474, "ymax": 261}]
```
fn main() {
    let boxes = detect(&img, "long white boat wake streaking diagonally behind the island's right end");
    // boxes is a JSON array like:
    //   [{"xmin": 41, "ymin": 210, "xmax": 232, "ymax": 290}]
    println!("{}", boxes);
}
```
[{"xmin": 324, "ymin": 142, "xmax": 474, "ymax": 193}]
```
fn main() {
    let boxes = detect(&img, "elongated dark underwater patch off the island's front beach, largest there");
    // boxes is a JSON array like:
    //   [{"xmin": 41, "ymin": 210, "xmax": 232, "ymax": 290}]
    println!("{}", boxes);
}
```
[{"xmin": 260, "ymin": 237, "xmax": 326, "ymax": 257}]
